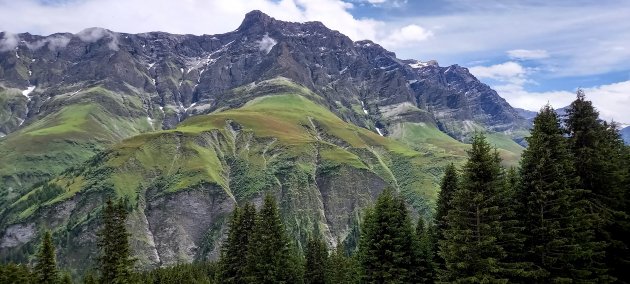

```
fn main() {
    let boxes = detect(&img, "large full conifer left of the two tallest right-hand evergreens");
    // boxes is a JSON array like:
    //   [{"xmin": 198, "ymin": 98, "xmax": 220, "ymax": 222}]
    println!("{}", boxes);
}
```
[{"xmin": 439, "ymin": 134, "xmax": 515, "ymax": 282}]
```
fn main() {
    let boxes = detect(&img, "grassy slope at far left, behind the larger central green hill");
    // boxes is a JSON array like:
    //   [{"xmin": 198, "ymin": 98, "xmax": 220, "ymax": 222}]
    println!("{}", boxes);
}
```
[{"xmin": 0, "ymin": 87, "xmax": 157, "ymax": 206}]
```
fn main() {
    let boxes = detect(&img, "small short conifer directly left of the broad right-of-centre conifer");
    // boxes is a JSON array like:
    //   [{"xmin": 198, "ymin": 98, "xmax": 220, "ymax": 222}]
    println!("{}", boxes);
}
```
[{"xmin": 327, "ymin": 240, "xmax": 360, "ymax": 284}]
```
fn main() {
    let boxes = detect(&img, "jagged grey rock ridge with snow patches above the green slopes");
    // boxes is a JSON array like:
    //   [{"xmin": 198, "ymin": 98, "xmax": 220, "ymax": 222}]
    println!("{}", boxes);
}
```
[{"xmin": 0, "ymin": 11, "xmax": 524, "ymax": 139}]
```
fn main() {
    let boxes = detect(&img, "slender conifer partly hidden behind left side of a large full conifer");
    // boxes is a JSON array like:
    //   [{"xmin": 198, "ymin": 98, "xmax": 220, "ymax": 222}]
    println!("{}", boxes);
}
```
[{"xmin": 434, "ymin": 163, "xmax": 459, "ymax": 270}]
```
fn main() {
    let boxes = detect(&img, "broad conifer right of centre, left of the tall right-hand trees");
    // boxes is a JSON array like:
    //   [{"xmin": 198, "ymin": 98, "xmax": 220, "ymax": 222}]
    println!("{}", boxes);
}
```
[{"xmin": 358, "ymin": 189, "xmax": 426, "ymax": 283}]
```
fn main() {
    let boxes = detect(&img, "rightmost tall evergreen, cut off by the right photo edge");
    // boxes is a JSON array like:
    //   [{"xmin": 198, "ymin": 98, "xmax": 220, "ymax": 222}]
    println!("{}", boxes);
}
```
[{"xmin": 565, "ymin": 90, "xmax": 630, "ymax": 282}]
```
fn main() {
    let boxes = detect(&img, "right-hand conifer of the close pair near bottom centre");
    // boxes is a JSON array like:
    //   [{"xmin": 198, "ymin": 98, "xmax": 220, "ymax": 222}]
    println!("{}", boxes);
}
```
[{"xmin": 247, "ymin": 194, "xmax": 302, "ymax": 283}]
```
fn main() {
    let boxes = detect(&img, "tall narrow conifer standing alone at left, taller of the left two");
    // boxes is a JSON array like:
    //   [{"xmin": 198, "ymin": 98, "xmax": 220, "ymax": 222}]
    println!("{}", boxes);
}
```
[{"xmin": 98, "ymin": 199, "xmax": 134, "ymax": 283}]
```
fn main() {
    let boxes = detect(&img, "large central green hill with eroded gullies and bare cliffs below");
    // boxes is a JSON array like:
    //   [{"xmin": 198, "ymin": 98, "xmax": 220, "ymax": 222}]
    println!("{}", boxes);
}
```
[{"xmin": 0, "ymin": 78, "xmax": 460, "ymax": 269}]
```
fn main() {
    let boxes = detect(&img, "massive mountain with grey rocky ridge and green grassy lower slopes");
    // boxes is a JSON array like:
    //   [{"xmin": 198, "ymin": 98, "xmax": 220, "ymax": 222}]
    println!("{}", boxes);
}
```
[{"xmin": 0, "ymin": 11, "xmax": 528, "ymax": 269}]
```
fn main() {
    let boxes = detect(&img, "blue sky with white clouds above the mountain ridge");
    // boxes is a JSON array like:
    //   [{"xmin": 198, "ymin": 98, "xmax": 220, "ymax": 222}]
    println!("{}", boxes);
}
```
[{"xmin": 0, "ymin": 0, "xmax": 630, "ymax": 123}]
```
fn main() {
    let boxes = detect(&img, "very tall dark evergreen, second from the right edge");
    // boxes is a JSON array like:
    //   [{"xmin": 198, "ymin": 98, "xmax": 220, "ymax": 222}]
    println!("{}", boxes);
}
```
[{"xmin": 517, "ymin": 105, "xmax": 605, "ymax": 283}]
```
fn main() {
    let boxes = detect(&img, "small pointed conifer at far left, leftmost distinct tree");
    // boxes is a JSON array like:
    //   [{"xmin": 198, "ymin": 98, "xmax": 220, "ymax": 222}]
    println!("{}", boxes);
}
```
[{"xmin": 33, "ymin": 231, "xmax": 59, "ymax": 284}]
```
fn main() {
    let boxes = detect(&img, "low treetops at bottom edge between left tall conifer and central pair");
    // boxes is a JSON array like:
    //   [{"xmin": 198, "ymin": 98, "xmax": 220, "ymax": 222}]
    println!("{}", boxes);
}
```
[{"xmin": 138, "ymin": 262, "xmax": 220, "ymax": 284}]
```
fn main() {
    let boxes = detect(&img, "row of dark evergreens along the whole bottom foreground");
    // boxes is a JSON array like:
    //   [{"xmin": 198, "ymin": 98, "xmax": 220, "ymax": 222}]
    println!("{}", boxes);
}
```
[{"xmin": 0, "ymin": 91, "xmax": 630, "ymax": 283}]
